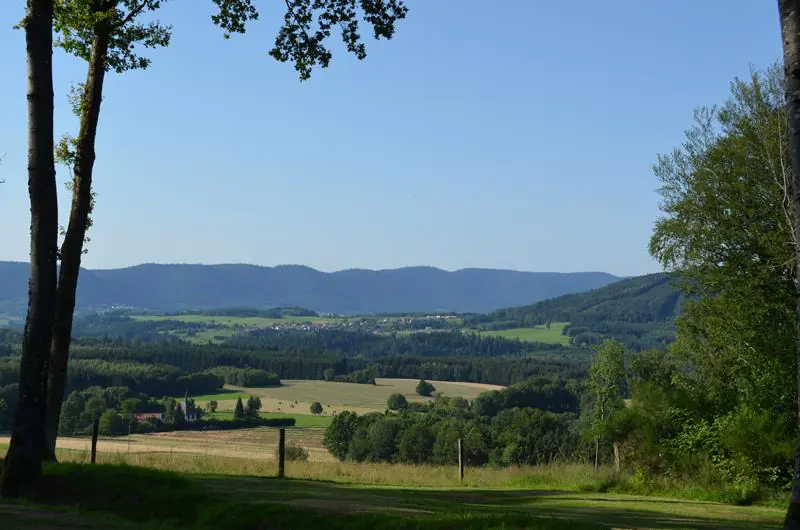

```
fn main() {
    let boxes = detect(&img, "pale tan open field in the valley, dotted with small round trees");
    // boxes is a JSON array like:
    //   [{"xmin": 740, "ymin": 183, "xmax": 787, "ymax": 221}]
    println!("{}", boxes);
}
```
[{"xmin": 194, "ymin": 379, "xmax": 502, "ymax": 416}]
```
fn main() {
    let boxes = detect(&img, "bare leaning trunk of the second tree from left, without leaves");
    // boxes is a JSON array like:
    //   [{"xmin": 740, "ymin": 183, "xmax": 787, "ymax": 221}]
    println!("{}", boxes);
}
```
[{"xmin": 45, "ymin": 20, "xmax": 111, "ymax": 460}]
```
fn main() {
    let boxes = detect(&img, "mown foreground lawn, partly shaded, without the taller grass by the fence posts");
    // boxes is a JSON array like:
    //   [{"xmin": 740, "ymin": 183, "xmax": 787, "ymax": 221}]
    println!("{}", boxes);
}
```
[{"xmin": 0, "ymin": 463, "xmax": 782, "ymax": 530}]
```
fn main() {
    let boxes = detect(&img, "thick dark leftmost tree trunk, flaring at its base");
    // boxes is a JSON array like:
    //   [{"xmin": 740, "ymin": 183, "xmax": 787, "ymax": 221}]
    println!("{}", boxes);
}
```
[{"xmin": 0, "ymin": 0, "xmax": 58, "ymax": 497}]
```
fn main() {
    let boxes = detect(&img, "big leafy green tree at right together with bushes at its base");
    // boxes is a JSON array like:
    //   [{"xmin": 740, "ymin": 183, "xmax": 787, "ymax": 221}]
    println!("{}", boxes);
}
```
[{"xmin": 648, "ymin": 65, "xmax": 797, "ymax": 492}]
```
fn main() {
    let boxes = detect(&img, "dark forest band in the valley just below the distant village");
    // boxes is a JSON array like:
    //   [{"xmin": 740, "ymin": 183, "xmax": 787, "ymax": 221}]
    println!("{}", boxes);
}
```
[{"xmin": 229, "ymin": 329, "xmax": 564, "ymax": 358}]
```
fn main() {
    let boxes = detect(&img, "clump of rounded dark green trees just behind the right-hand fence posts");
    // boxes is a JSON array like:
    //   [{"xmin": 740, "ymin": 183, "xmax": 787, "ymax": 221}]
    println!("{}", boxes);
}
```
[{"xmin": 323, "ymin": 379, "xmax": 589, "ymax": 466}]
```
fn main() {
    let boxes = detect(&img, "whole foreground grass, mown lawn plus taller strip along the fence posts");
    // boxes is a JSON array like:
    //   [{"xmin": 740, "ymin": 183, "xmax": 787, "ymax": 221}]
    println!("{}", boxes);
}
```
[{"xmin": 0, "ymin": 451, "xmax": 783, "ymax": 530}]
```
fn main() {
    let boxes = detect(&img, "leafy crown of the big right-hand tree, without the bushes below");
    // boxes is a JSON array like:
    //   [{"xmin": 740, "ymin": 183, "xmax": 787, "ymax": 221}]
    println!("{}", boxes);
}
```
[{"xmin": 650, "ymin": 66, "xmax": 796, "ymax": 422}]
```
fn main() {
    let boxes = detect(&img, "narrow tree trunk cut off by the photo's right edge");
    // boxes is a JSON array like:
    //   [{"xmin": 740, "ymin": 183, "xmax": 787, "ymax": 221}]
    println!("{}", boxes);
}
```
[{"xmin": 778, "ymin": 0, "xmax": 800, "ymax": 530}]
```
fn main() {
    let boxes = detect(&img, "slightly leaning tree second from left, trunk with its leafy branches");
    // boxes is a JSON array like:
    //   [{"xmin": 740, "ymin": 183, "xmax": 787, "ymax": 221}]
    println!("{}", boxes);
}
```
[{"xmin": 45, "ymin": 0, "xmax": 170, "ymax": 460}]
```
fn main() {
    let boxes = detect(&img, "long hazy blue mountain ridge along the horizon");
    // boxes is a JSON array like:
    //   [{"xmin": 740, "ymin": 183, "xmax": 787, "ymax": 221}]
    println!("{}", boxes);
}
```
[{"xmin": 0, "ymin": 262, "xmax": 620, "ymax": 314}]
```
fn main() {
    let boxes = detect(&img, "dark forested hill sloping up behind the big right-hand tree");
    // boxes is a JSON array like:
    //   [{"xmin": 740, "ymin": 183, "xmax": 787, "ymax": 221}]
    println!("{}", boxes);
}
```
[{"xmin": 466, "ymin": 273, "xmax": 683, "ymax": 349}]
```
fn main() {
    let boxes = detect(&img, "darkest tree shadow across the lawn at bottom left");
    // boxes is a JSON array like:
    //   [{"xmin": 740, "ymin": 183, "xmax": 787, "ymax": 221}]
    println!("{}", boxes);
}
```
[{"xmin": 0, "ymin": 464, "xmax": 608, "ymax": 530}]
